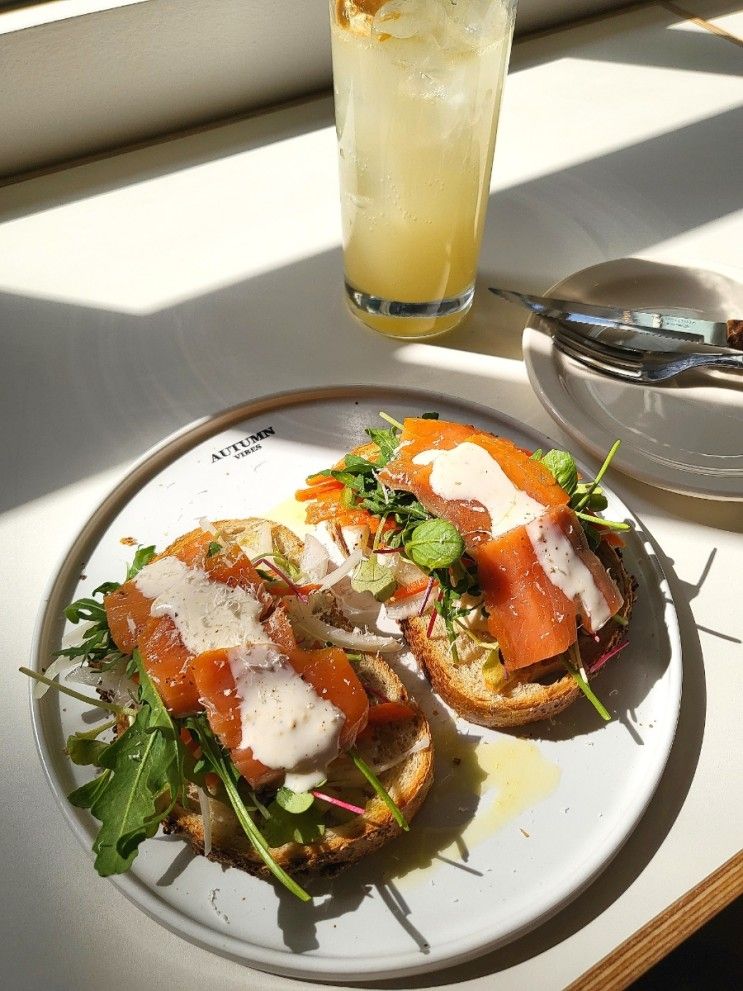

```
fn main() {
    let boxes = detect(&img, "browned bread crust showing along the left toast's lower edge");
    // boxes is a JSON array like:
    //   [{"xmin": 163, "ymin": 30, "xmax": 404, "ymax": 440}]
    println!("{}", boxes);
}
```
[{"xmin": 163, "ymin": 655, "xmax": 433, "ymax": 879}]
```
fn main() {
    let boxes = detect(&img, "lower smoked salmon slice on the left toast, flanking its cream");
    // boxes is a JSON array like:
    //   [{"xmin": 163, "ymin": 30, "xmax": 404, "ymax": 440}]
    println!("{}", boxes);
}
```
[{"xmin": 191, "ymin": 647, "xmax": 369, "ymax": 788}]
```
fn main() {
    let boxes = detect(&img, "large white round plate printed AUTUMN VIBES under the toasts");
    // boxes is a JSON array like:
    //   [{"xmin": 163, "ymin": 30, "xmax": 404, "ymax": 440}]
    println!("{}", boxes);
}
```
[{"xmin": 32, "ymin": 387, "xmax": 681, "ymax": 980}]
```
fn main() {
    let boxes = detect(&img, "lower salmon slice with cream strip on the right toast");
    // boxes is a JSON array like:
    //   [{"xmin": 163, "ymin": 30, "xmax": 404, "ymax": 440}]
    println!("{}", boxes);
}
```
[{"xmin": 474, "ymin": 506, "xmax": 623, "ymax": 670}]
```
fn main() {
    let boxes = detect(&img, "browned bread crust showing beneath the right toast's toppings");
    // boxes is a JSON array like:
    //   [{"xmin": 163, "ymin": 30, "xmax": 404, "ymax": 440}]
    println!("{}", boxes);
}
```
[{"xmin": 401, "ymin": 544, "xmax": 637, "ymax": 727}]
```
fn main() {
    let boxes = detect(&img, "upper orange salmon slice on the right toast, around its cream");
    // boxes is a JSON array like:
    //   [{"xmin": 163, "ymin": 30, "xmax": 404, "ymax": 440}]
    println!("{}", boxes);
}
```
[{"xmin": 379, "ymin": 418, "xmax": 569, "ymax": 551}]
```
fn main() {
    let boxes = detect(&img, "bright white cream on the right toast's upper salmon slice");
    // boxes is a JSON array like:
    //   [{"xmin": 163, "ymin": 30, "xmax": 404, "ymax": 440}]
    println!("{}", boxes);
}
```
[{"xmin": 413, "ymin": 441, "xmax": 545, "ymax": 537}]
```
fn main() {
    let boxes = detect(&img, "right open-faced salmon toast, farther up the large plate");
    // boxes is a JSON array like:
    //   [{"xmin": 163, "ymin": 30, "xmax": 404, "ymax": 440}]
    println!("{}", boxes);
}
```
[{"xmin": 297, "ymin": 414, "xmax": 635, "ymax": 727}]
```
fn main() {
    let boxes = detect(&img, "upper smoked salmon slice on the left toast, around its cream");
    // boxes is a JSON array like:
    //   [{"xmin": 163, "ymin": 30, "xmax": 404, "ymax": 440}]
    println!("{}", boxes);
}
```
[{"xmin": 103, "ymin": 530, "xmax": 280, "ymax": 716}]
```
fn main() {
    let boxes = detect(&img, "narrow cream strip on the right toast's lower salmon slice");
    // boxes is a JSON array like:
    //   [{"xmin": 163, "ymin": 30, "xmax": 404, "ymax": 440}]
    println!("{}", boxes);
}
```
[{"xmin": 526, "ymin": 519, "xmax": 611, "ymax": 632}]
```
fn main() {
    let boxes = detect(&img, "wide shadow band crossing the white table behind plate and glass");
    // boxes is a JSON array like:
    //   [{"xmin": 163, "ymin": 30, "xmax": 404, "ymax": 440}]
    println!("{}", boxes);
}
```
[{"xmin": 0, "ymin": 103, "xmax": 739, "ymax": 509}]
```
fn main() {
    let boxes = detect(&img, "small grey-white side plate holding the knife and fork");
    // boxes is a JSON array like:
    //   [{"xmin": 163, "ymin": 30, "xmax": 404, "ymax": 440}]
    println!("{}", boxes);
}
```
[{"xmin": 523, "ymin": 258, "xmax": 743, "ymax": 500}]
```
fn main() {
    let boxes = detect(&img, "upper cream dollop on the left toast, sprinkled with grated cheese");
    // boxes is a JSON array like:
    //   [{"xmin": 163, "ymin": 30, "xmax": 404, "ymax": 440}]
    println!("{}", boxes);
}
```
[{"xmin": 134, "ymin": 557, "xmax": 266, "ymax": 654}]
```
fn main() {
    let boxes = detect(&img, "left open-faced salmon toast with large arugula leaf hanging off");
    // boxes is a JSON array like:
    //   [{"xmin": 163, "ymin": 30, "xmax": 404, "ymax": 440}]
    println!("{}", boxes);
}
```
[{"xmin": 27, "ymin": 519, "xmax": 433, "ymax": 899}]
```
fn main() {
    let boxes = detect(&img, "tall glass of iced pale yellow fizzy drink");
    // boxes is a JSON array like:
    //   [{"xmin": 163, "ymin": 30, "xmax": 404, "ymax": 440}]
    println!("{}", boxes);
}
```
[{"xmin": 330, "ymin": 0, "xmax": 516, "ymax": 338}]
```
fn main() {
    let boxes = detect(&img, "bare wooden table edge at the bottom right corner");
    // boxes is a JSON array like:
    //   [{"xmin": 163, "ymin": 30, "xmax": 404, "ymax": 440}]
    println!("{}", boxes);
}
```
[{"xmin": 565, "ymin": 850, "xmax": 743, "ymax": 991}]
